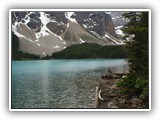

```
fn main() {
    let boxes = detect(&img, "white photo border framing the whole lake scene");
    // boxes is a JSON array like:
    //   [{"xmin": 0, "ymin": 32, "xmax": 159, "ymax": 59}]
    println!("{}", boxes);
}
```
[{"xmin": 9, "ymin": 9, "xmax": 152, "ymax": 111}]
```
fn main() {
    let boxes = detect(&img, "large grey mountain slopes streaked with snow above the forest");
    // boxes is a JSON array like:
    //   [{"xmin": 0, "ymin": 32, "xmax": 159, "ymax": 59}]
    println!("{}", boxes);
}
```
[{"xmin": 12, "ymin": 11, "xmax": 124, "ymax": 56}]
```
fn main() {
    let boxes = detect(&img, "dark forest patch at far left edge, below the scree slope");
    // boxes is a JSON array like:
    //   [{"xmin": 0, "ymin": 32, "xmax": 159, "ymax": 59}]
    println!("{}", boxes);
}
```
[{"xmin": 11, "ymin": 32, "xmax": 40, "ymax": 60}]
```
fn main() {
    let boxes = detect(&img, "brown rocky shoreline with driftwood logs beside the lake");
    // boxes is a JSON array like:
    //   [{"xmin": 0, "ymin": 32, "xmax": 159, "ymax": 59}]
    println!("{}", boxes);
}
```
[{"xmin": 96, "ymin": 77, "xmax": 149, "ymax": 109}]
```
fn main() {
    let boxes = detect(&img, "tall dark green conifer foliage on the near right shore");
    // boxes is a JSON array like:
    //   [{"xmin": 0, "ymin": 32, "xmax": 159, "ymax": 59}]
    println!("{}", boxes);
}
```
[{"xmin": 117, "ymin": 12, "xmax": 149, "ymax": 100}]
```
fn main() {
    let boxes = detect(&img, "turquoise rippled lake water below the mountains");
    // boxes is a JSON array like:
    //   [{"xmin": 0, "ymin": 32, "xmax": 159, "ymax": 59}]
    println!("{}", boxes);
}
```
[{"xmin": 11, "ymin": 59, "xmax": 127, "ymax": 108}]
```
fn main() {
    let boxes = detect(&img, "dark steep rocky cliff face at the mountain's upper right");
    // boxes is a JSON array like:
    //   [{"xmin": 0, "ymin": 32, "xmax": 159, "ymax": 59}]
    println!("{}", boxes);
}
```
[{"xmin": 72, "ymin": 12, "xmax": 115, "ymax": 36}]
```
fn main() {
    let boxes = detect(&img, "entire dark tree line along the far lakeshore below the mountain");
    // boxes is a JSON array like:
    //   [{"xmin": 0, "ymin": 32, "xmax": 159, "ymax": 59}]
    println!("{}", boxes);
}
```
[{"xmin": 11, "ymin": 32, "xmax": 126, "ymax": 60}]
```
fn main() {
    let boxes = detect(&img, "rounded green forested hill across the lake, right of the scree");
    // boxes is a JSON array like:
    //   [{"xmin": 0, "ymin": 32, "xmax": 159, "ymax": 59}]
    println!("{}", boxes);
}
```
[{"xmin": 52, "ymin": 43, "xmax": 126, "ymax": 59}]
